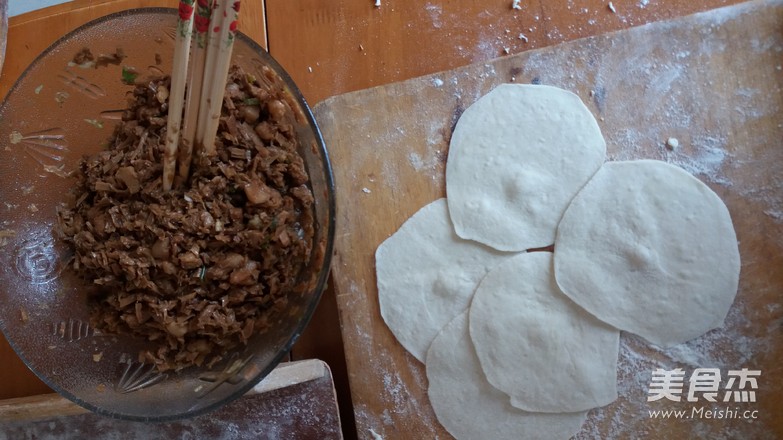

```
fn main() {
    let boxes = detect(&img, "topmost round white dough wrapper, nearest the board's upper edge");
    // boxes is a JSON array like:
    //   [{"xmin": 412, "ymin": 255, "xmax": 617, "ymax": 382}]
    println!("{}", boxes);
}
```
[{"xmin": 446, "ymin": 84, "xmax": 606, "ymax": 251}]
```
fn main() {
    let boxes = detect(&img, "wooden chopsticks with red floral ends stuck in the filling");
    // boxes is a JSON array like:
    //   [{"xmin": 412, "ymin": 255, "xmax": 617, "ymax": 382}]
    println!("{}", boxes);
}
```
[{"xmin": 163, "ymin": 0, "xmax": 240, "ymax": 191}]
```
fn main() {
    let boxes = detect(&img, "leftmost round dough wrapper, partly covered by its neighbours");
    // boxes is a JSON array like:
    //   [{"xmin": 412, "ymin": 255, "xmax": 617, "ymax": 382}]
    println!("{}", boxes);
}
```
[{"xmin": 375, "ymin": 199, "xmax": 508, "ymax": 362}]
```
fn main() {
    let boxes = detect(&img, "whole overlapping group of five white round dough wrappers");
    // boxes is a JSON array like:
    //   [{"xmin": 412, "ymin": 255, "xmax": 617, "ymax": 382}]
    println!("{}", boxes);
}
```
[{"xmin": 376, "ymin": 84, "xmax": 740, "ymax": 439}]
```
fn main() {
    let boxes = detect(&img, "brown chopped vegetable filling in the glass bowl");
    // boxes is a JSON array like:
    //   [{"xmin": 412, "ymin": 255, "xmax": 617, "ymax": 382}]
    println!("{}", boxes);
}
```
[{"xmin": 58, "ymin": 67, "xmax": 315, "ymax": 371}]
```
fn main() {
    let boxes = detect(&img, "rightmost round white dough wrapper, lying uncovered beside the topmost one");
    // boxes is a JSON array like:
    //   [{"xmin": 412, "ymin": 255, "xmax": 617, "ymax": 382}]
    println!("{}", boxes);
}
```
[{"xmin": 555, "ymin": 160, "xmax": 740, "ymax": 347}]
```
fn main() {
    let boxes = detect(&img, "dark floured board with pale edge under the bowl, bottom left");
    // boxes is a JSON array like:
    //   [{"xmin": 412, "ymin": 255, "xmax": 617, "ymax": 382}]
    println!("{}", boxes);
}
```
[{"xmin": 0, "ymin": 359, "xmax": 343, "ymax": 440}]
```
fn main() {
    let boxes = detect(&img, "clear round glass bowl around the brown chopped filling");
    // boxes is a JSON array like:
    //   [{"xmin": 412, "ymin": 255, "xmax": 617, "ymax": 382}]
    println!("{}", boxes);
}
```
[{"xmin": 0, "ymin": 8, "xmax": 335, "ymax": 421}]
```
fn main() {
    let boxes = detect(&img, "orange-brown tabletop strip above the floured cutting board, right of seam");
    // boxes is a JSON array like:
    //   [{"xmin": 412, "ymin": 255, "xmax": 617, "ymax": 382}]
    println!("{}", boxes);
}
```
[{"xmin": 267, "ymin": 0, "xmax": 738, "ymax": 103}]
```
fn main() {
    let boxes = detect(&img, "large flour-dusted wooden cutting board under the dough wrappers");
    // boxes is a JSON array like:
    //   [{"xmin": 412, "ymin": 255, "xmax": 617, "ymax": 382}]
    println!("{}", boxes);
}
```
[{"xmin": 315, "ymin": 0, "xmax": 783, "ymax": 440}]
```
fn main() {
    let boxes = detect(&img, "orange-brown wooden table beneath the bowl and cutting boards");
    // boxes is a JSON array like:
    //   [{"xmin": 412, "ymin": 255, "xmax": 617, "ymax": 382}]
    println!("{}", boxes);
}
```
[{"xmin": 0, "ymin": 0, "xmax": 748, "ymax": 438}]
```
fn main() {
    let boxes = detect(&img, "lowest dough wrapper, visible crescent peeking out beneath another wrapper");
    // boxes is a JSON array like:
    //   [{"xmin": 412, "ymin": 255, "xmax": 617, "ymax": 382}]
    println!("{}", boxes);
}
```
[{"xmin": 427, "ymin": 312, "xmax": 587, "ymax": 440}]
